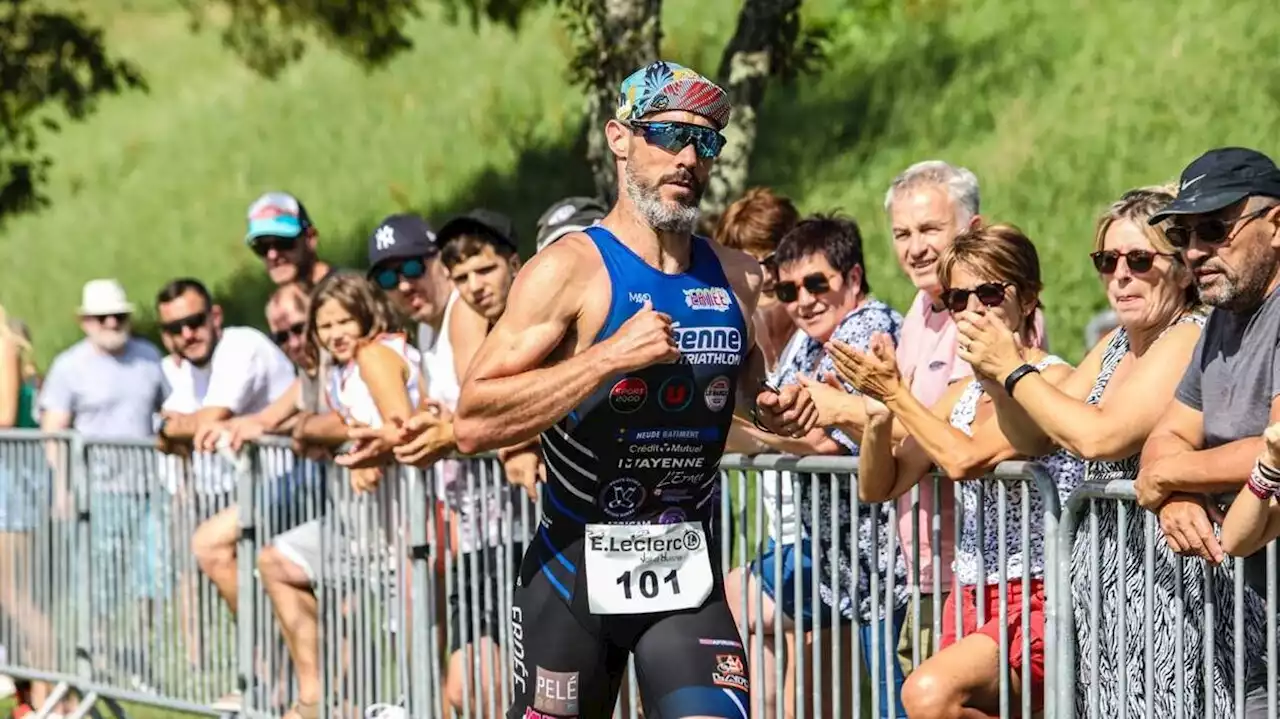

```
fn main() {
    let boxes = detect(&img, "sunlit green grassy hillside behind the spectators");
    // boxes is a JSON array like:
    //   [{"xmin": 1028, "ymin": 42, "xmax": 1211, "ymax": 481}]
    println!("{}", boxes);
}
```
[{"xmin": 0, "ymin": 0, "xmax": 1280, "ymax": 363}]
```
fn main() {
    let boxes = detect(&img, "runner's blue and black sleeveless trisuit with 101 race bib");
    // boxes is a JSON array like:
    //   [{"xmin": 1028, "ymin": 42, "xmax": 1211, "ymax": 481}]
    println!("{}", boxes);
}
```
[{"xmin": 508, "ymin": 226, "xmax": 750, "ymax": 719}]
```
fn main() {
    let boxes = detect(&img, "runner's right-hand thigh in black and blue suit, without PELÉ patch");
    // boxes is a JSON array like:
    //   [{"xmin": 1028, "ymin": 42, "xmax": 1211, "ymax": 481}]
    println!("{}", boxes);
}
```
[{"xmin": 635, "ymin": 592, "xmax": 751, "ymax": 719}]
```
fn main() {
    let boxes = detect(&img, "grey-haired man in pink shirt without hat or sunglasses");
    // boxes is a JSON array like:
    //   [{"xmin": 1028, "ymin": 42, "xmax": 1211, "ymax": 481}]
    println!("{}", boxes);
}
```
[{"xmin": 884, "ymin": 160, "xmax": 1047, "ymax": 672}]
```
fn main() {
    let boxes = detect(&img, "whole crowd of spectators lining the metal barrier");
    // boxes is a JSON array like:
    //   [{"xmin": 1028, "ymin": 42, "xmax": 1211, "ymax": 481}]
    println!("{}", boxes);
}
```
[{"xmin": 0, "ymin": 89, "xmax": 1280, "ymax": 719}]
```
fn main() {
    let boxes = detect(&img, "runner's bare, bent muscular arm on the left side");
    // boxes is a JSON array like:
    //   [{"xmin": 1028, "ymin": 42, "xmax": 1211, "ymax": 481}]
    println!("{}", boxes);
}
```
[{"xmin": 453, "ymin": 235, "xmax": 620, "ymax": 454}]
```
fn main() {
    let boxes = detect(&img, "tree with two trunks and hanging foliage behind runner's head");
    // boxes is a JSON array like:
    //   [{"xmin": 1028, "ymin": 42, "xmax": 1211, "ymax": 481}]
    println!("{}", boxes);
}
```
[{"xmin": 192, "ymin": 0, "xmax": 829, "ymax": 207}]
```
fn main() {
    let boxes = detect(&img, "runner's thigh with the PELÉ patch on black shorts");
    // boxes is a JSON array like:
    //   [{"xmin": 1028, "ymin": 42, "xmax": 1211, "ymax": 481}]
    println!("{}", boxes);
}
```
[{"xmin": 507, "ymin": 571, "xmax": 627, "ymax": 719}]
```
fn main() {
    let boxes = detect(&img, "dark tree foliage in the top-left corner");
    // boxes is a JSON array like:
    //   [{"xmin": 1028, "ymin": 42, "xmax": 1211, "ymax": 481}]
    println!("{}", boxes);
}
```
[{"xmin": 0, "ymin": 0, "xmax": 146, "ymax": 219}]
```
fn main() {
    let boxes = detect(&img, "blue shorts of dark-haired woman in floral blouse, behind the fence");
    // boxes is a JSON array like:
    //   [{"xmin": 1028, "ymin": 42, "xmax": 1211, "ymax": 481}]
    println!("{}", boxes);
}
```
[{"xmin": 751, "ymin": 537, "xmax": 906, "ymax": 716}]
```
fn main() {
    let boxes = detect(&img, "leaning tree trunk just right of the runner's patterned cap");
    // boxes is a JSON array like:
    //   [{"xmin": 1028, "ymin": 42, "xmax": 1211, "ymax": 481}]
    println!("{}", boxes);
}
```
[{"xmin": 701, "ymin": 0, "xmax": 800, "ymax": 216}]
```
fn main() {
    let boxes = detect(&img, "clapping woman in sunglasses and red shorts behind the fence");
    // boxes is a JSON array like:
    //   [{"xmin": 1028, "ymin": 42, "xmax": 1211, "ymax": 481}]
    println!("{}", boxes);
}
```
[{"xmin": 832, "ymin": 225, "xmax": 1084, "ymax": 719}]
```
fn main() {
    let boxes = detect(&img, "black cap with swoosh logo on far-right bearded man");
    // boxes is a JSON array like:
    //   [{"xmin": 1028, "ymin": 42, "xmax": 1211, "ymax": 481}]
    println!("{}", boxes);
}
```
[{"xmin": 1148, "ymin": 147, "xmax": 1280, "ymax": 225}]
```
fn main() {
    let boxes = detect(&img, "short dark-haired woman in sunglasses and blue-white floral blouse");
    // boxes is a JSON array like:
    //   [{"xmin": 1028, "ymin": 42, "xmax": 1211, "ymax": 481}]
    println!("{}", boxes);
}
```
[{"xmin": 726, "ymin": 216, "xmax": 908, "ymax": 716}]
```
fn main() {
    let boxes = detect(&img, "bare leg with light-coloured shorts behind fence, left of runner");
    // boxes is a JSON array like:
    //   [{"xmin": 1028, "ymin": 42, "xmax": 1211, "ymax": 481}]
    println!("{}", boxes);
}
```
[{"xmin": 257, "ymin": 519, "xmax": 321, "ymax": 716}]
